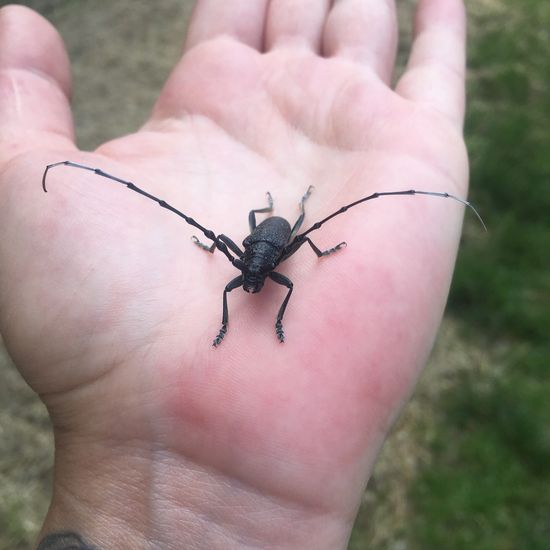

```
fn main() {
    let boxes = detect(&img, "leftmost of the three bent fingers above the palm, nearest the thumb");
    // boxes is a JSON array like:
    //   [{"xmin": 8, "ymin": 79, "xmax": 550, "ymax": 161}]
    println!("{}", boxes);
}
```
[{"xmin": 184, "ymin": 0, "xmax": 268, "ymax": 51}]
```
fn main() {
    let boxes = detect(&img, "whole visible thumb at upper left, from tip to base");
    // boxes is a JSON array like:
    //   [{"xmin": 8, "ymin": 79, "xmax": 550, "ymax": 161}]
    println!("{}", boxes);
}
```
[{"xmin": 0, "ymin": 5, "xmax": 74, "ymax": 160}]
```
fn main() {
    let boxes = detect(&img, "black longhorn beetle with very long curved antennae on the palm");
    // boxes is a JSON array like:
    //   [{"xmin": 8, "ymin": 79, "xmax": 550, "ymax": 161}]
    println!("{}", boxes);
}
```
[{"xmin": 42, "ymin": 160, "xmax": 486, "ymax": 347}]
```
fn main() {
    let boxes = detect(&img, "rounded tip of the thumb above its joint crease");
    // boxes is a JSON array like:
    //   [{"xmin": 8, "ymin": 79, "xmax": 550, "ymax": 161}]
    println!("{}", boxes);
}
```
[{"xmin": 0, "ymin": 4, "xmax": 71, "ymax": 98}]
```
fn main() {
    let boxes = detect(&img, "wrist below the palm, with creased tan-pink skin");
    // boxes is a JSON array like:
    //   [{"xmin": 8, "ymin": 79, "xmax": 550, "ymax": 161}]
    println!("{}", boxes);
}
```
[{"xmin": 40, "ymin": 441, "xmax": 351, "ymax": 550}]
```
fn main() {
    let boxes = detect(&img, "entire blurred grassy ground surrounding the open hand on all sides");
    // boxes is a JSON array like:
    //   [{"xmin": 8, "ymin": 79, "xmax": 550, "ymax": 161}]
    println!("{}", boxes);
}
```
[{"xmin": 0, "ymin": 0, "xmax": 550, "ymax": 550}]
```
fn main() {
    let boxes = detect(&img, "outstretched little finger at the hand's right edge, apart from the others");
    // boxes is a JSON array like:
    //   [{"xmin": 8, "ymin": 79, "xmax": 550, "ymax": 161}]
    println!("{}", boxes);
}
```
[{"xmin": 396, "ymin": 0, "xmax": 466, "ymax": 126}]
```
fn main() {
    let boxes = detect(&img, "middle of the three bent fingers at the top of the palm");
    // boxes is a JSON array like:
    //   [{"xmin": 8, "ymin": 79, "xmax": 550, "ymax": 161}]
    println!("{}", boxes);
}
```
[{"xmin": 265, "ymin": 0, "xmax": 330, "ymax": 52}]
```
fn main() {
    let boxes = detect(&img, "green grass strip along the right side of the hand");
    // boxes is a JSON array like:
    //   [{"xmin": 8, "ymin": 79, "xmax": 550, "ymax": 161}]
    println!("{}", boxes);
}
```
[{"xmin": 410, "ymin": 0, "xmax": 550, "ymax": 550}]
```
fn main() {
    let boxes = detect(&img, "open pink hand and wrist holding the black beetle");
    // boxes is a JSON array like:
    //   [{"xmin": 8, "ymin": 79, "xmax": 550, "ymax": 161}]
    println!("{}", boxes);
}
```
[{"xmin": 0, "ymin": 0, "xmax": 468, "ymax": 549}]
